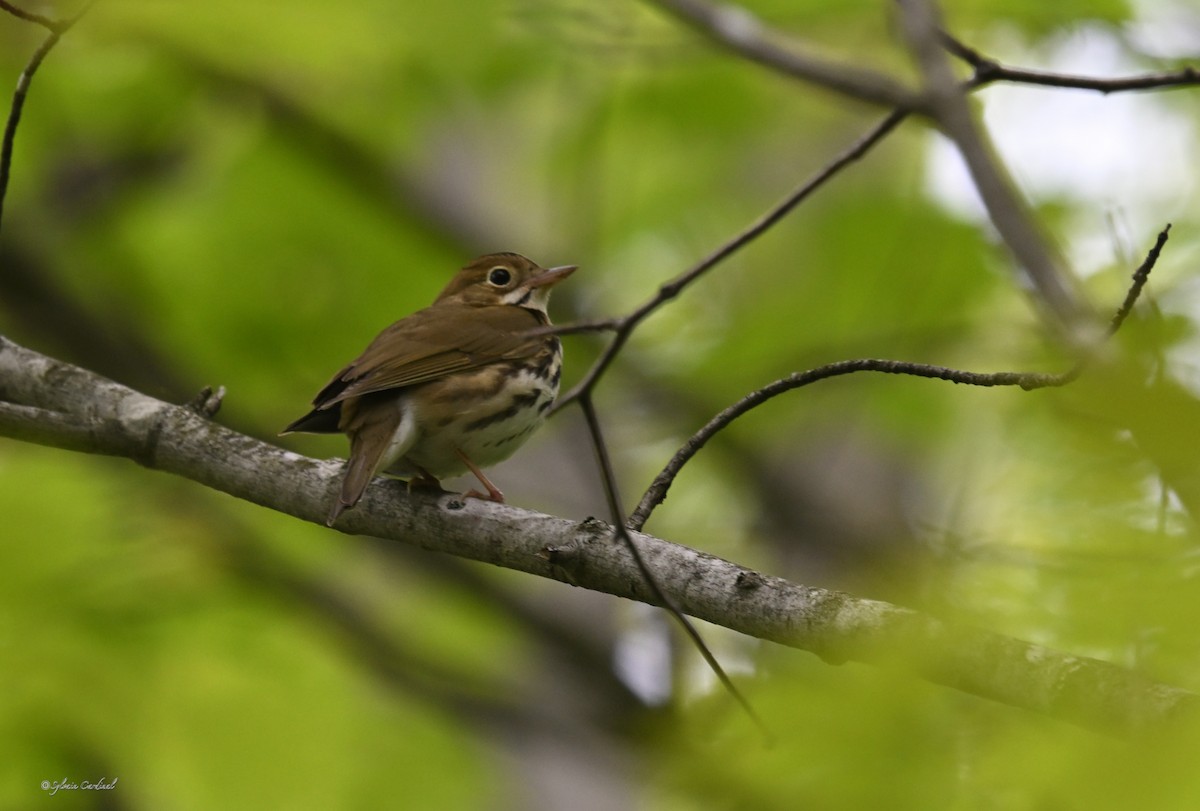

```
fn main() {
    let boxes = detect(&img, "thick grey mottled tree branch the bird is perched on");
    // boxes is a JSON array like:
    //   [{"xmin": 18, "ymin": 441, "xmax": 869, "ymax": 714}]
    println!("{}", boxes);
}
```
[{"xmin": 0, "ymin": 338, "xmax": 1200, "ymax": 733}]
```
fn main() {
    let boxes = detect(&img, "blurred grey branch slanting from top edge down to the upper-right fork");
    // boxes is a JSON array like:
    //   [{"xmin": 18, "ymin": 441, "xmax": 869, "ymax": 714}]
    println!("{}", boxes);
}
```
[{"xmin": 648, "ymin": 0, "xmax": 924, "ymax": 110}]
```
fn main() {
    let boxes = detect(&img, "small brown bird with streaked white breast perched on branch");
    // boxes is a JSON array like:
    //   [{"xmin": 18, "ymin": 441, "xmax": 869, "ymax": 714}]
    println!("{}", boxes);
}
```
[{"xmin": 282, "ymin": 253, "xmax": 575, "ymax": 525}]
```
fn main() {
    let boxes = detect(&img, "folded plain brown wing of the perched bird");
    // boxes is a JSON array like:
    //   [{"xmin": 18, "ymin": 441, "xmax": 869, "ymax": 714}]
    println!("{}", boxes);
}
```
[{"xmin": 313, "ymin": 305, "xmax": 547, "ymax": 410}]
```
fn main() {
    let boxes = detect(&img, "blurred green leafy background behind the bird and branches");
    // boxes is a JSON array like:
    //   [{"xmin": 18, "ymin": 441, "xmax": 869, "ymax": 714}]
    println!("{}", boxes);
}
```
[{"xmin": 0, "ymin": 0, "xmax": 1200, "ymax": 811}]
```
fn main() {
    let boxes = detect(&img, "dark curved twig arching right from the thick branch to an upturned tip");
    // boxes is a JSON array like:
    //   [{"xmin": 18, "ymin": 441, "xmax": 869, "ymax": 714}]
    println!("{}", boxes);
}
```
[{"xmin": 629, "ymin": 224, "xmax": 1171, "ymax": 529}]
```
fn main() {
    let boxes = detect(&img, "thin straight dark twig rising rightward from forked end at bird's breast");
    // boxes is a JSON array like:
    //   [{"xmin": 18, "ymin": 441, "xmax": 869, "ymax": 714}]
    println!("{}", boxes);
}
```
[{"xmin": 546, "ymin": 110, "xmax": 907, "ymax": 411}]
